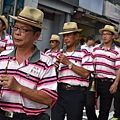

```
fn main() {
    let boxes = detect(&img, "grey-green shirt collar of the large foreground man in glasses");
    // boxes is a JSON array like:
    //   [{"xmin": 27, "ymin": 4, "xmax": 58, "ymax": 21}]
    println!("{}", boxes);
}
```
[{"xmin": 8, "ymin": 46, "xmax": 40, "ymax": 63}]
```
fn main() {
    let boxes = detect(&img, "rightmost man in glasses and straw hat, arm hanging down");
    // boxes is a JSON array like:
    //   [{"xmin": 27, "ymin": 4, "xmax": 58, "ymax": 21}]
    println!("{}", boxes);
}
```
[{"xmin": 86, "ymin": 25, "xmax": 120, "ymax": 120}]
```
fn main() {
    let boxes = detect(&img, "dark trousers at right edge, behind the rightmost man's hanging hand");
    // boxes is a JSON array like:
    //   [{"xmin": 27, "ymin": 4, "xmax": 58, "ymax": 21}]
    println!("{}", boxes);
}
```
[{"xmin": 114, "ymin": 83, "xmax": 120, "ymax": 119}]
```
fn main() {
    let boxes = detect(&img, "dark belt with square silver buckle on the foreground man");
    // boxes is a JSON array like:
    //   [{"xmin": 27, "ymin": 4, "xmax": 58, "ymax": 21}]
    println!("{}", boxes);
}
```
[{"xmin": 0, "ymin": 109, "xmax": 38, "ymax": 118}]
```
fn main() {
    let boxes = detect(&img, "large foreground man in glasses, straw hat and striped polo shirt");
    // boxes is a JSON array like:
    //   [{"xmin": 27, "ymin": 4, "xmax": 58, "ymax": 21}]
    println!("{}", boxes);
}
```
[{"xmin": 0, "ymin": 6, "xmax": 57, "ymax": 120}]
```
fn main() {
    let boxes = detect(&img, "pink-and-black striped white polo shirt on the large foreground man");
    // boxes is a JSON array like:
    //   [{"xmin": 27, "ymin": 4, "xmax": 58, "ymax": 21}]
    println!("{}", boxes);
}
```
[{"xmin": 0, "ymin": 48, "xmax": 57, "ymax": 115}]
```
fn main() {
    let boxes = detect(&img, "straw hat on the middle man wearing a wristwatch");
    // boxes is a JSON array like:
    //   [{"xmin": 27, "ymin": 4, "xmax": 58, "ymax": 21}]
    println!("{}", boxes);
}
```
[{"xmin": 59, "ymin": 22, "xmax": 82, "ymax": 34}]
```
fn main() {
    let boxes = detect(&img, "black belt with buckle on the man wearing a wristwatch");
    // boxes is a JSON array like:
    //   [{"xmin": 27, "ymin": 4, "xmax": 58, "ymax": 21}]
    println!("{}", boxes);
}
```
[{"xmin": 58, "ymin": 83, "xmax": 87, "ymax": 92}]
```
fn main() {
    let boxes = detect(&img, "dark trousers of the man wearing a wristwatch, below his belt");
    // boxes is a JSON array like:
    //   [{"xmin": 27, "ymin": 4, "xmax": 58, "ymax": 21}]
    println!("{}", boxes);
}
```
[{"xmin": 51, "ymin": 84, "xmax": 85, "ymax": 120}]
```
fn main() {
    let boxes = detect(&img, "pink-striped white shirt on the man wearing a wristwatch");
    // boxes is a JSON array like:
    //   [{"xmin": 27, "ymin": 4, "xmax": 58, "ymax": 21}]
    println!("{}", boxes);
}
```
[{"xmin": 58, "ymin": 45, "xmax": 94, "ymax": 87}]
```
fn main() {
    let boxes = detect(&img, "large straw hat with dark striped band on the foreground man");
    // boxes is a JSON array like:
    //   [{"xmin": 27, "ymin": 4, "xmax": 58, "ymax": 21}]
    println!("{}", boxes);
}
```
[{"xmin": 9, "ymin": 6, "xmax": 47, "ymax": 29}]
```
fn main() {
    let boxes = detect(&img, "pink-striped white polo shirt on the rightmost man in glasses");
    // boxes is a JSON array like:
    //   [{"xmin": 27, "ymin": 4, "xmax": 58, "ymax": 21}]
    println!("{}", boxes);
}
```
[{"xmin": 93, "ymin": 43, "xmax": 120, "ymax": 79}]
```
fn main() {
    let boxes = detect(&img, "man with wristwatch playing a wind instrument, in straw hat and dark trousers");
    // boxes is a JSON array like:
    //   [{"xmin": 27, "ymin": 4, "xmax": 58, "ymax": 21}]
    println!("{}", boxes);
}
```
[{"xmin": 51, "ymin": 22, "xmax": 93, "ymax": 120}]
